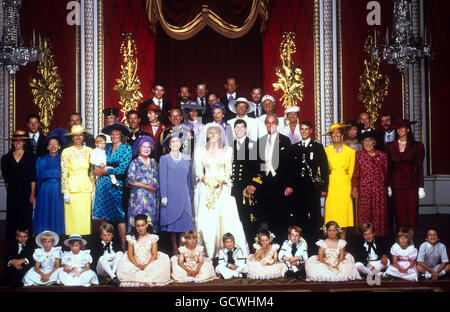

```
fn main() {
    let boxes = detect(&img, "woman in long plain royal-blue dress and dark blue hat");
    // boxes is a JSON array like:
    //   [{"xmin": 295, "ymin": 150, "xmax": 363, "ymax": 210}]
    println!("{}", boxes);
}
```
[{"xmin": 33, "ymin": 130, "xmax": 66, "ymax": 235}]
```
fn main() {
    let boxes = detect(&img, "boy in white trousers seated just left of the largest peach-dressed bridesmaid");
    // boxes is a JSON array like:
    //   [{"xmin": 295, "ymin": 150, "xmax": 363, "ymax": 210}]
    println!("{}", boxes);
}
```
[{"xmin": 92, "ymin": 223, "xmax": 123, "ymax": 285}]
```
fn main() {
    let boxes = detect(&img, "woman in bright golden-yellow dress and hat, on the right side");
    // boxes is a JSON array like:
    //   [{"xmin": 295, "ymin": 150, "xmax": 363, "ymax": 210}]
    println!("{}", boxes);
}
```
[{"xmin": 325, "ymin": 123, "xmax": 355, "ymax": 239}]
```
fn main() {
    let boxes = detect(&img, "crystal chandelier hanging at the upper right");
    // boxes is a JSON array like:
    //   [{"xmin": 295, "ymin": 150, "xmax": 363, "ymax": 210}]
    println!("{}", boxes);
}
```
[{"xmin": 372, "ymin": 0, "xmax": 432, "ymax": 74}]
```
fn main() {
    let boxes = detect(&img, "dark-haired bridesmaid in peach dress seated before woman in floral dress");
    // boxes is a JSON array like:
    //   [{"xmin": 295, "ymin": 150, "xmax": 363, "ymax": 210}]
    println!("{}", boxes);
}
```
[{"xmin": 117, "ymin": 214, "xmax": 170, "ymax": 287}]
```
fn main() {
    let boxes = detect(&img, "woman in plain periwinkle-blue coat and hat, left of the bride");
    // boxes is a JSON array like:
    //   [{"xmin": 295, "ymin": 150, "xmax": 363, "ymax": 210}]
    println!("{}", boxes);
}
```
[{"xmin": 159, "ymin": 132, "xmax": 193, "ymax": 254}]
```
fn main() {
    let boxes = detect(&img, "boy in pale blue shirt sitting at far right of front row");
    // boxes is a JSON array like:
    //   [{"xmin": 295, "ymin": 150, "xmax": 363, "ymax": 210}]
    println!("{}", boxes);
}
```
[{"xmin": 417, "ymin": 228, "xmax": 450, "ymax": 280}]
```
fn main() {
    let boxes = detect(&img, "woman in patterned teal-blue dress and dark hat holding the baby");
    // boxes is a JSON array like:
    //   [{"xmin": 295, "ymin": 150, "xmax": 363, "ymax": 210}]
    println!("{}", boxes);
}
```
[{"xmin": 92, "ymin": 122, "xmax": 133, "ymax": 250}]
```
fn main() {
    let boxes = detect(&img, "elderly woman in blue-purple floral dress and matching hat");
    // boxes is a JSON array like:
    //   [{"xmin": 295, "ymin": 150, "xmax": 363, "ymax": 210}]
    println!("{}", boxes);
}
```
[{"xmin": 127, "ymin": 136, "xmax": 159, "ymax": 232}]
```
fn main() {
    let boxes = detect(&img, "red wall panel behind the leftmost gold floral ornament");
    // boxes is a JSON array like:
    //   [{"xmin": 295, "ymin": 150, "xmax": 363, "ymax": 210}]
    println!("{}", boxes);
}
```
[{"xmin": 16, "ymin": 0, "xmax": 76, "ymax": 130}]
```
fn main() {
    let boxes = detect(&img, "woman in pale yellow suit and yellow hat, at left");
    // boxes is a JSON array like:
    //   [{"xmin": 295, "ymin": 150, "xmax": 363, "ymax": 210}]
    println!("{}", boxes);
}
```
[{"xmin": 61, "ymin": 125, "xmax": 94, "ymax": 235}]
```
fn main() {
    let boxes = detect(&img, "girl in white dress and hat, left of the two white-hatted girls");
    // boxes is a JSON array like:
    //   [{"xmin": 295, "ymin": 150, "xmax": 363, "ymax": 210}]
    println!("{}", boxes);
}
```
[{"xmin": 23, "ymin": 231, "xmax": 62, "ymax": 286}]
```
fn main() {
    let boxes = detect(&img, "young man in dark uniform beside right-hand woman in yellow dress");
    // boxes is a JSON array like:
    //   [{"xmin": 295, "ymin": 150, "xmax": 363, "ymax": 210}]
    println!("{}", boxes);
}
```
[{"xmin": 291, "ymin": 121, "xmax": 330, "ymax": 247}]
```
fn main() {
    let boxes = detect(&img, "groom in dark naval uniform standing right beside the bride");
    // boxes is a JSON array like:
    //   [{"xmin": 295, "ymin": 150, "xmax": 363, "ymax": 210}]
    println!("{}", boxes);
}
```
[{"xmin": 231, "ymin": 119, "xmax": 261, "ymax": 245}]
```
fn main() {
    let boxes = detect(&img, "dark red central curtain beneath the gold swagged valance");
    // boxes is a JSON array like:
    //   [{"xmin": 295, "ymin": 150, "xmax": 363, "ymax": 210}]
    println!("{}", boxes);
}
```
[{"xmin": 155, "ymin": 24, "xmax": 263, "ymax": 105}]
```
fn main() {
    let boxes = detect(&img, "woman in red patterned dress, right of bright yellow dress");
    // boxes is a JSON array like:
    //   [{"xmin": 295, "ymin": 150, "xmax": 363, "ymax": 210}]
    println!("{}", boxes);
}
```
[{"xmin": 352, "ymin": 131, "xmax": 389, "ymax": 236}]
